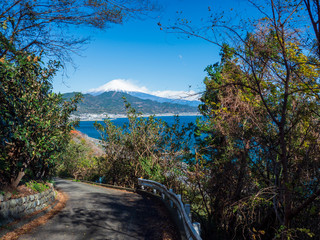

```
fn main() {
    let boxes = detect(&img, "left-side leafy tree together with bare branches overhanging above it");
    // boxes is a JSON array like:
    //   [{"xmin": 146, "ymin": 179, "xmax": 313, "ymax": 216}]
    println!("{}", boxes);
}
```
[{"xmin": 0, "ymin": 0, "xmax": 153, "ymax": 189}]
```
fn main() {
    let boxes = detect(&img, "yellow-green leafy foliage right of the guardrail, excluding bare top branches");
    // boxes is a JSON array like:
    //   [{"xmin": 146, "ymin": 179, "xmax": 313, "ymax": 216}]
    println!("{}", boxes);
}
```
[{"xmin": 189, "ymin": 36, "xmax": 320, "ymax": 239}]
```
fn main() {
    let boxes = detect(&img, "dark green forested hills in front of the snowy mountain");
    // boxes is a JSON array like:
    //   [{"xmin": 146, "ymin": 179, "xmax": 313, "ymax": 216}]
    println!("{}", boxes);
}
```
[{"xmin": 63, "ymin": 91, "xmax": 198, "ymax": 114}]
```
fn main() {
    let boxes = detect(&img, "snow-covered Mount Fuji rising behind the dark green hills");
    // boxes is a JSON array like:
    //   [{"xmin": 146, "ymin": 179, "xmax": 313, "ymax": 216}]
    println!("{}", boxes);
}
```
[{"xmin": 85, "ymin": 79, "xmax": 200, "ymax": 107}]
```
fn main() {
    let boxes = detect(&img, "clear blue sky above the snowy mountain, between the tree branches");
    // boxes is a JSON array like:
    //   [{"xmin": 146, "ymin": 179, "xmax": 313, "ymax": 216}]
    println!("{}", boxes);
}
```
[{"xmin": 53, "ymin": 0, "xmax": 252, "ymax": 93}]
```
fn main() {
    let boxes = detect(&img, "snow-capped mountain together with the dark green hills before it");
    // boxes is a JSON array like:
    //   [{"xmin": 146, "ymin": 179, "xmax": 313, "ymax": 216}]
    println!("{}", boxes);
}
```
[{"xmin": 64, "ymin": 79, "xmax": 200, "ymax": 115}]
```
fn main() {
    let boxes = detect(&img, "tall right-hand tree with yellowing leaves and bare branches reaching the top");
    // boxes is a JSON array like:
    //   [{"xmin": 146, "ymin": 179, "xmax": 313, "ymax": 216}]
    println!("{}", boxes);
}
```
[{"xmin": 164, "ymin": 0, "xmax": 320, "ymax": 239}]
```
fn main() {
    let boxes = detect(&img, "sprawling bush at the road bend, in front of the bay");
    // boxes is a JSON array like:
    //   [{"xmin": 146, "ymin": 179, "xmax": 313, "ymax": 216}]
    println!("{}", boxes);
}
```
[{"xmin": 95, "ymin": 100, "xmax": 191, "ymax": 187}]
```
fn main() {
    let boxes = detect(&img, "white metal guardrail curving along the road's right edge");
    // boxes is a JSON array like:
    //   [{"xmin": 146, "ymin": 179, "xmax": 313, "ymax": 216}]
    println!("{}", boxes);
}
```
[{"xmin": 138, "ymin": 178, "xmax": 202, "ymax": 240}]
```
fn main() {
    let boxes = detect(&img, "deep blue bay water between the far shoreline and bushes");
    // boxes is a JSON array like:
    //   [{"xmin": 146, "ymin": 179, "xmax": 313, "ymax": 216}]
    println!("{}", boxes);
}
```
[{"xmin": 76, "ymin": 116, "xmax": 199, "ymax": 139}]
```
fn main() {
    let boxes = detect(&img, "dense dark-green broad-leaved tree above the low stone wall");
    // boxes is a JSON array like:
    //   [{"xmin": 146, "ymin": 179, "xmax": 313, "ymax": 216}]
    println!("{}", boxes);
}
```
[{"xmin": 0, "ymin": 50, "xmax": 80, "ymax": 187}]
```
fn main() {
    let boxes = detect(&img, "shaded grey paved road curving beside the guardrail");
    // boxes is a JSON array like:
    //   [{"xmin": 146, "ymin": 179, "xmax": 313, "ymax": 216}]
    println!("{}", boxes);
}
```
[{"xmin": 19, "ymin": 180, "xmax": 179, "ymax": 240}]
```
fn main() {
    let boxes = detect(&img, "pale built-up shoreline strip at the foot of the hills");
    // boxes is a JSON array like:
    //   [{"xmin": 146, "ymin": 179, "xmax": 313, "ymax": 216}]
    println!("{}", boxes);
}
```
[{"xmin": 71, "ymin": 112, "xmax": 202, "ymax": 121}]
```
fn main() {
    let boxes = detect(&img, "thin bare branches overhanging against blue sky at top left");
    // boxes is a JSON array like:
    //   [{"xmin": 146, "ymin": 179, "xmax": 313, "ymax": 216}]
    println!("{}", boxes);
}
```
[{"xmin": 0, "ymin": 0, "xmax": 154, "ymax": 60}]
